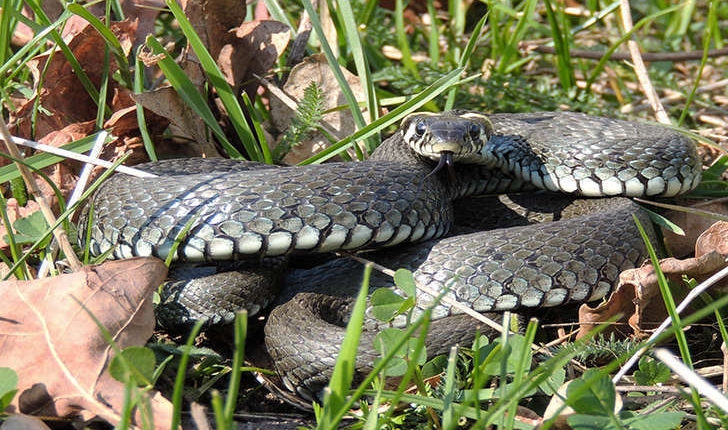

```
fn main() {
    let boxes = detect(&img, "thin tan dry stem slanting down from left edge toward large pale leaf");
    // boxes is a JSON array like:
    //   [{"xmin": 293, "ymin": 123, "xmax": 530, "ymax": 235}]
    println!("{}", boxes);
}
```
[{"xmin": 0, "ymin": 118, "xmax": 83, "ymax": 271}]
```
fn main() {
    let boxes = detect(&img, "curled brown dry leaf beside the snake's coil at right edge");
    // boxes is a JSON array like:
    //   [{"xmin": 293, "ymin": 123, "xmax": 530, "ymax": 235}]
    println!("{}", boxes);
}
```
[{"xmin": 577, "ymin": 221, "xmax": 728, "ymax": 337}]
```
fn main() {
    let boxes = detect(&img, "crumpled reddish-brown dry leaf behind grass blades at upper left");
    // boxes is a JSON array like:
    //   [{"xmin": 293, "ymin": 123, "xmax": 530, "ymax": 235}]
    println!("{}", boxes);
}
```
[{"xmin": 11, "ymin": 19, "xmax": 156, "ymax": 211}]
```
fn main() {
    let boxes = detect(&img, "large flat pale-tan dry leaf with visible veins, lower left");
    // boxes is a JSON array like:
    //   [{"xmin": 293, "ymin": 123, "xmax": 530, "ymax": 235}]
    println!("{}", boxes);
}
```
[{"xmin": 0, "ymin": 258, "xmax": 171, "ymax": 429}]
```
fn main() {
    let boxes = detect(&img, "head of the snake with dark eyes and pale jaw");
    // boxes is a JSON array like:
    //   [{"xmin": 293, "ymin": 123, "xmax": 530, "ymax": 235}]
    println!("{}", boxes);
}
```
[{"xmin": 400, "ymin": 111, "xmax": 493, "ymax": 164}]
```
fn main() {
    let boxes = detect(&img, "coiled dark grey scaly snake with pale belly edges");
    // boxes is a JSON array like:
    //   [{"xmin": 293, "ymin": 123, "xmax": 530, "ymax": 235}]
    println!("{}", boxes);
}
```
[{"xmin": 79, "ymin": 111, "xmax": 702, "ymax": 398}]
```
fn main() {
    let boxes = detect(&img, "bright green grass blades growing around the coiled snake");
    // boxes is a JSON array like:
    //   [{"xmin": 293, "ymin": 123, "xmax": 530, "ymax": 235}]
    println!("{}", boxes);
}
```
[{"xmin": 0, "ymin": 0, "xmax": 728, "ymax": 429}]
